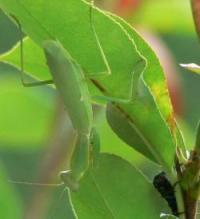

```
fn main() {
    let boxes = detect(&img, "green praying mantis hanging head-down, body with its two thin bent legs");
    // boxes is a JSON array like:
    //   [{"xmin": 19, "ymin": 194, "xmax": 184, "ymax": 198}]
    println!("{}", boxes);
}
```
[{"xmin": 12, "ymin": 1, "xmax": 114, "ymax": 191}]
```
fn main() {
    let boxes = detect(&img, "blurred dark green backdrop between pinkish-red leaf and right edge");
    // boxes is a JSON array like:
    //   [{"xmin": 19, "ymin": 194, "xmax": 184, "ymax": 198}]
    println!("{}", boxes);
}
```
[{"xmin": 161, "ymin": 33, "xmax": 200, "ymax": 137}]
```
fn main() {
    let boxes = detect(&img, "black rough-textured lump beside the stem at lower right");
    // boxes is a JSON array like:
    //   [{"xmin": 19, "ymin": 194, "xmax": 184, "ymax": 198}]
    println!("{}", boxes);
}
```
[{"xmin": 153, "ymin": 172, "xmax": 179, "ymax": 216}]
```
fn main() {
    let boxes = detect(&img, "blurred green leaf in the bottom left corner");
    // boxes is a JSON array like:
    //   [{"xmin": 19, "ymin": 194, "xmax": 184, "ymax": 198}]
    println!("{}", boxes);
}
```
[{"xmin": 0, "ymin": 165, "xmax": 22, "ymax": 219}]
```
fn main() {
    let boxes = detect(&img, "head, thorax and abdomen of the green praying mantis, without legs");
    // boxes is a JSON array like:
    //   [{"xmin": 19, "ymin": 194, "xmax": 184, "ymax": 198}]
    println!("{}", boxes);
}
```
[{"xmin": 43, "ymin": 40, "xmax": 97, "ymax": 190}]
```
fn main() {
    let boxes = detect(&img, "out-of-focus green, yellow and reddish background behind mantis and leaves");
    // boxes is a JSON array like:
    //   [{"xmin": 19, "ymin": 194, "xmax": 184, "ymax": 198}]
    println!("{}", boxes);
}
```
[{"xmin": 0, "ymin": 0, "xmax": 200, "ymax": 219}]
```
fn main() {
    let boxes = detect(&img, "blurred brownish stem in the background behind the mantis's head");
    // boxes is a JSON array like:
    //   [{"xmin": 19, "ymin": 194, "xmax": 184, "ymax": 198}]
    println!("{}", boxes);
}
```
[{"xmin": 23, "ymin": 97, "xmax": 75, "ymax": 219}]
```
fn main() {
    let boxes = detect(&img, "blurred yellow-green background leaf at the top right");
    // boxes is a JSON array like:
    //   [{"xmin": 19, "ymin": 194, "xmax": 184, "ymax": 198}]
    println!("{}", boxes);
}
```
[{"xmin": 130, "ymin": 0, "xmax": 195, "ymax": 34}]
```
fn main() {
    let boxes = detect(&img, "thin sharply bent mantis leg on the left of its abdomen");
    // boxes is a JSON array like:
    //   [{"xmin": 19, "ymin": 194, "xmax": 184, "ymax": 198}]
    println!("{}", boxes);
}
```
[{"xmin": 11, "ymin": 15, "xmax": 53, "ymax": 87}]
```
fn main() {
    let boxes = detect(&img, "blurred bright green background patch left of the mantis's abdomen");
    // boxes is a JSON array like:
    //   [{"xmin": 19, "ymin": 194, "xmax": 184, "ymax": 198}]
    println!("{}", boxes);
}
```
[{"xmin": 0, "ymin": 70, "xmax": 53, "ymax": 147}]
